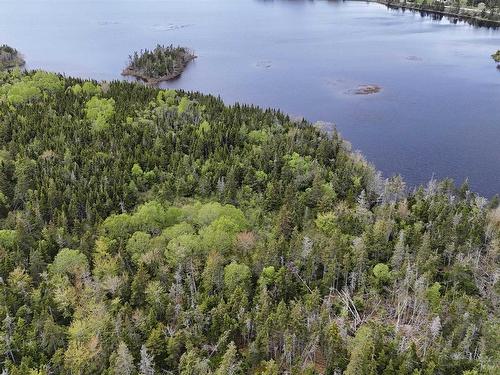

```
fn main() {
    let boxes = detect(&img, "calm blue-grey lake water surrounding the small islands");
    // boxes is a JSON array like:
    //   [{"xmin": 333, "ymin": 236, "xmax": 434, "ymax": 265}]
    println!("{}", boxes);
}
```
[{"xmin": 0, "ymin": 0, "xmax": 500, "ymax": 196}]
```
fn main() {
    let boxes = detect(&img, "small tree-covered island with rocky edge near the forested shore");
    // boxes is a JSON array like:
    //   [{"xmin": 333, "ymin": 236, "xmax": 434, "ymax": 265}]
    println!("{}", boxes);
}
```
[{"xmin": 122, "ymin": 45, "xmax": 196, "ymax": 84}]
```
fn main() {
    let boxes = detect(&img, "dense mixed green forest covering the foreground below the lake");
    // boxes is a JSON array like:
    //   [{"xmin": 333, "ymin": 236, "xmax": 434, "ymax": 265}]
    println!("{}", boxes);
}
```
[{"xmin": 0, "ymin": 70, "xmax": 500, "ymax": 375}]
